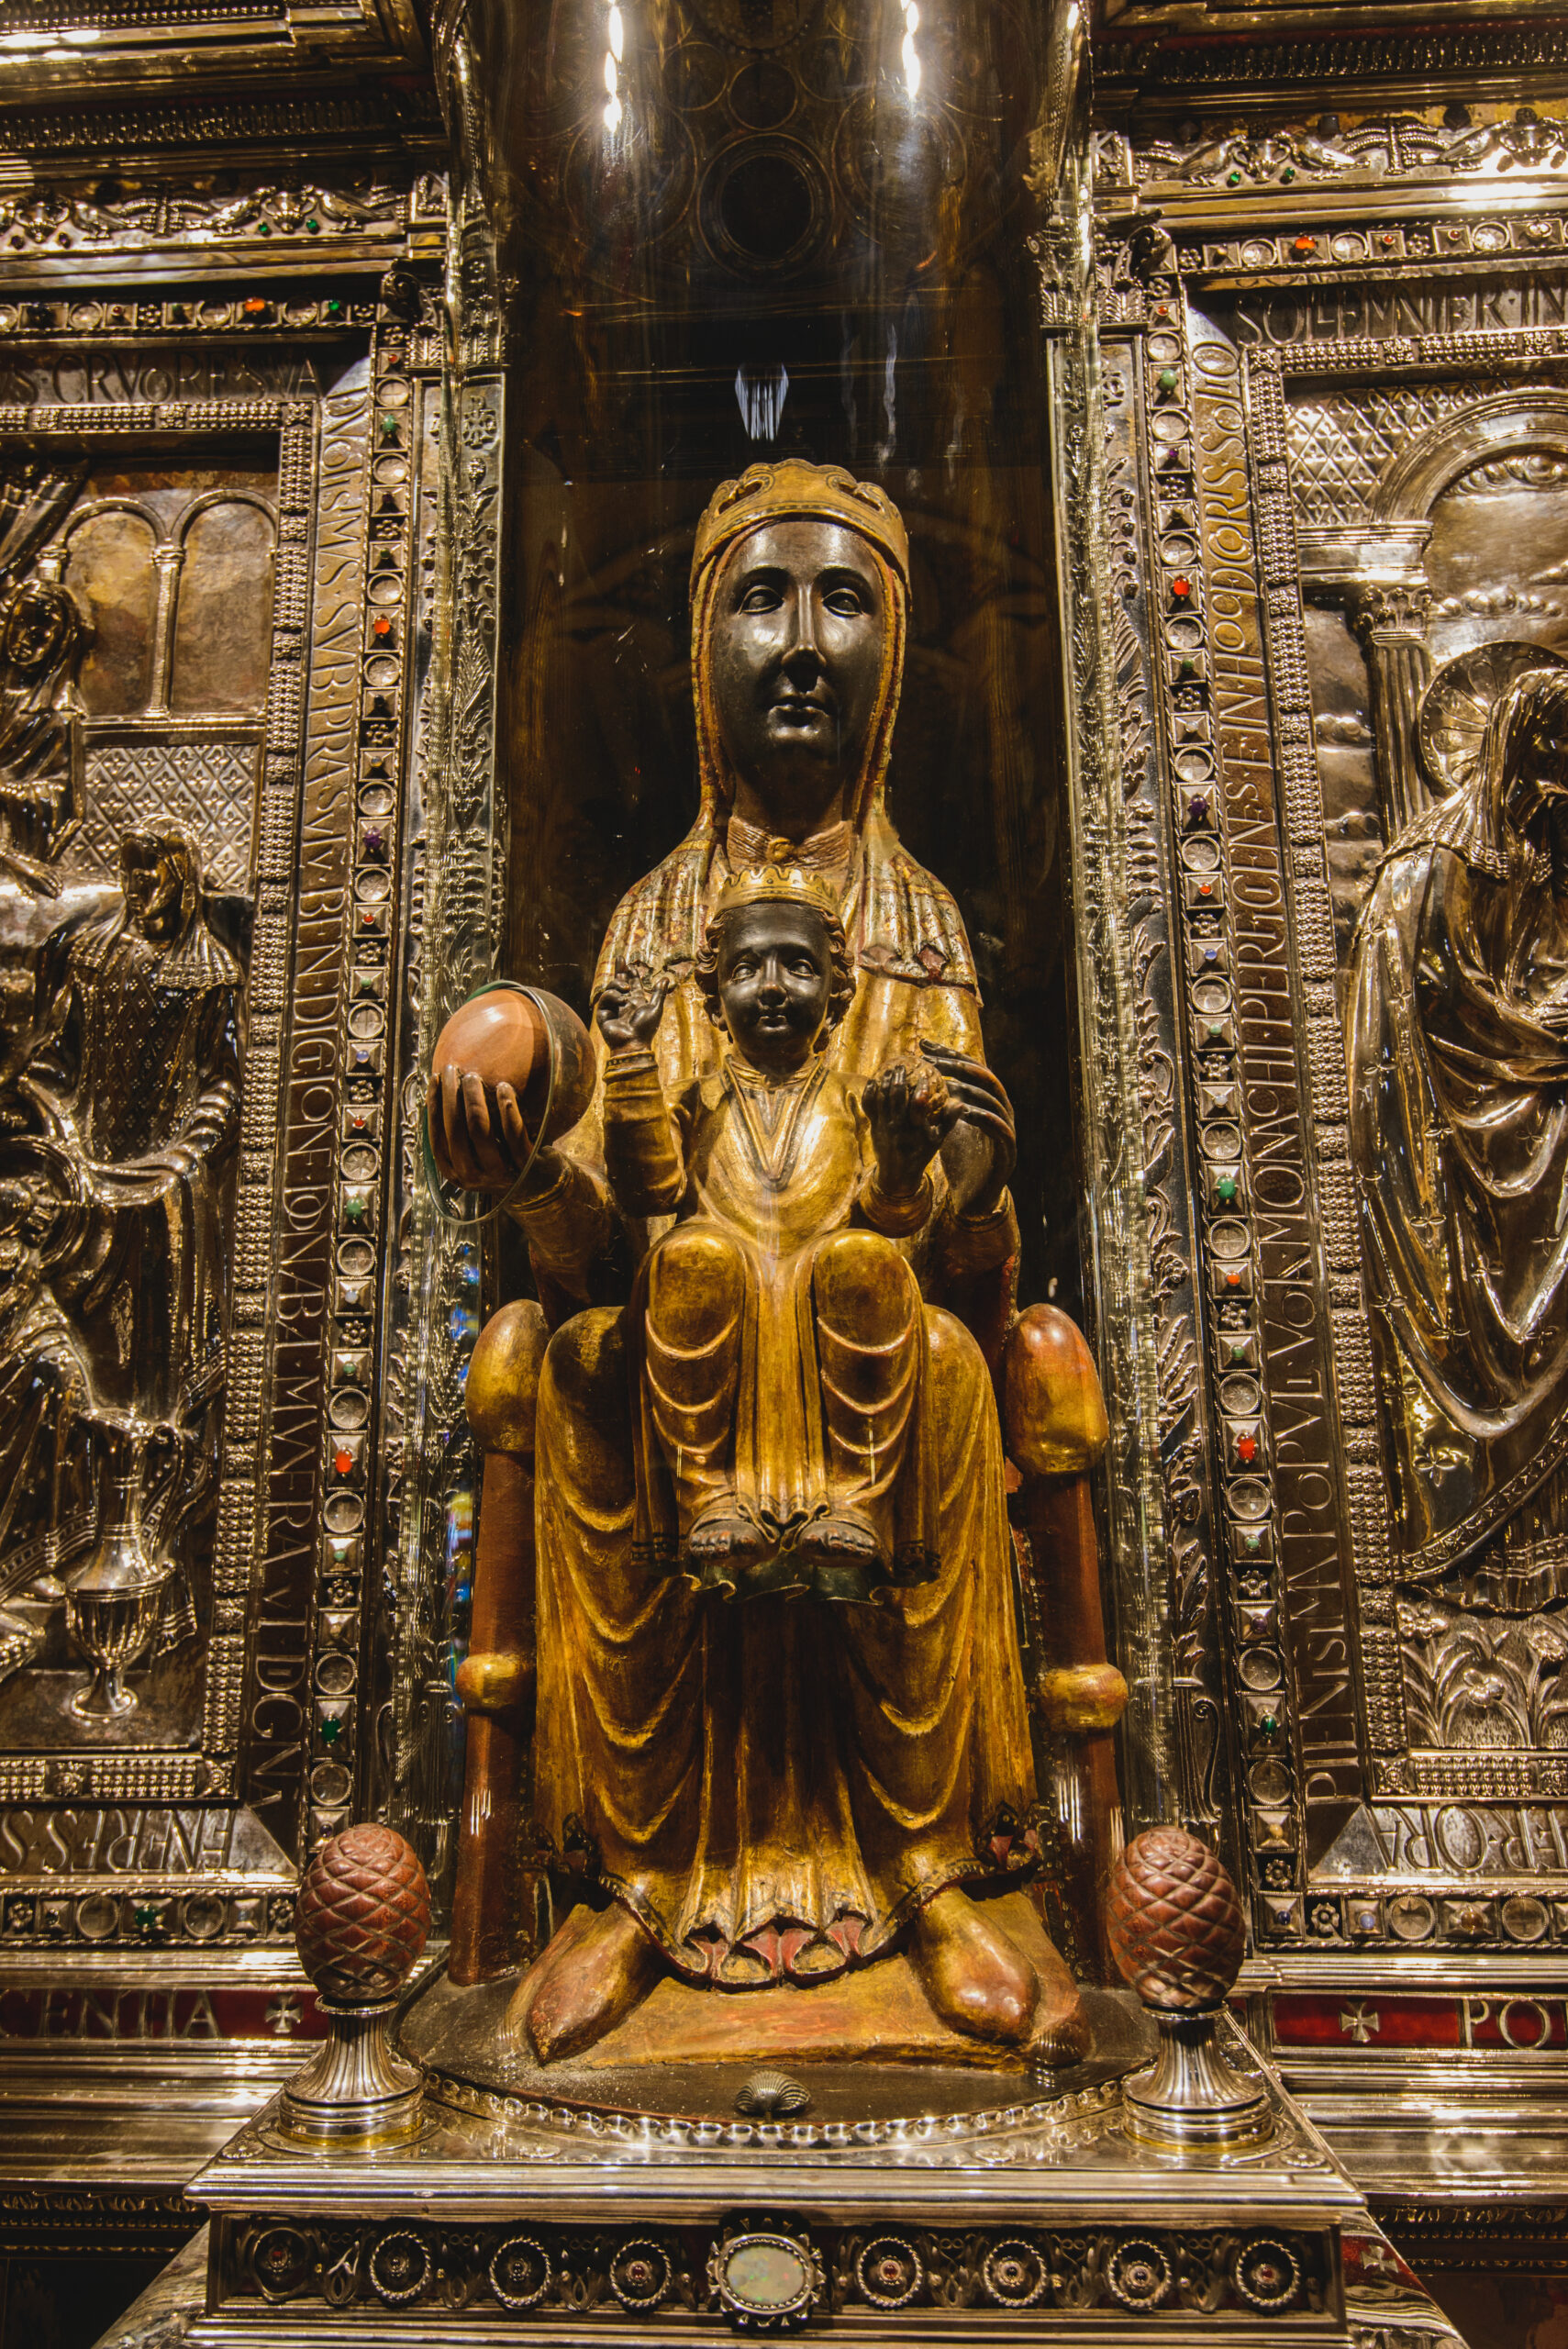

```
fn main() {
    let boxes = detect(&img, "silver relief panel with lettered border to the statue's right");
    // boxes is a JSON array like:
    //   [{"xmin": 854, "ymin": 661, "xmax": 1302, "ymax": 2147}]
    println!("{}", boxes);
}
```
[{"xmin": 1151, "ymin": 224, "xmax": 1568, "ymax": 1947}]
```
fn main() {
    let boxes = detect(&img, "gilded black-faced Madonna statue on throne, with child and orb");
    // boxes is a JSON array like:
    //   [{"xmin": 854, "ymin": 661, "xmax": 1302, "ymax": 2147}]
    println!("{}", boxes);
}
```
[{"xmin": 429, "ymin": 461, "xmax": 1124, "ymax": 2063}]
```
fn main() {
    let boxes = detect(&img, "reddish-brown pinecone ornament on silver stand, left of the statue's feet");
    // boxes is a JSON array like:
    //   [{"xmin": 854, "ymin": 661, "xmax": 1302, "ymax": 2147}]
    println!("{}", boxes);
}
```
[{"xmin": 294, "ymin": 1825, "xmax": 429, "ymax": 2006}]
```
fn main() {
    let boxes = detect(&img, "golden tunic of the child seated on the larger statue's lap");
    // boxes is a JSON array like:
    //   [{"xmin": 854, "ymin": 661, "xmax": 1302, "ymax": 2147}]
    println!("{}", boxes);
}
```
[{"xmin": 604, "ymin": 1050, "xmax": 937, "ymax": 1598}]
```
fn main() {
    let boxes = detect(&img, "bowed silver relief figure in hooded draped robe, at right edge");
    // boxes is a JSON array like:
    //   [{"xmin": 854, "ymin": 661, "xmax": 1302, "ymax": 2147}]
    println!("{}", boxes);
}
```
[{"xmin": 1348, "ymin": 664, "xmax": 1568, "ymax": 1609}]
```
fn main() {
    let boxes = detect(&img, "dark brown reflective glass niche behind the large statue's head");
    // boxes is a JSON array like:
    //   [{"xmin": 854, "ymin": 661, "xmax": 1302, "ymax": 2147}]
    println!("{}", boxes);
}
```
[{"xmin": 460, "ymin": 0, "xmax": 1080, "ymax": 1304}]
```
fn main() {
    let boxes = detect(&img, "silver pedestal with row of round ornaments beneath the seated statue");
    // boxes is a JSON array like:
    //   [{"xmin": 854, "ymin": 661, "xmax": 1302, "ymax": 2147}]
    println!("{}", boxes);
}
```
[{"xmin": 188, "ymin": 1992, "xmax": 1366, "ymax": 2349}]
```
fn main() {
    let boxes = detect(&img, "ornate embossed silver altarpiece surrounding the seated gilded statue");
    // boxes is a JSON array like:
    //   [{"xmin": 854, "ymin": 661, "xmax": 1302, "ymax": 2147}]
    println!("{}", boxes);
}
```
[{"xmin": 0, "ymin": 0, "xmax": 1568, "ymax": 2344}]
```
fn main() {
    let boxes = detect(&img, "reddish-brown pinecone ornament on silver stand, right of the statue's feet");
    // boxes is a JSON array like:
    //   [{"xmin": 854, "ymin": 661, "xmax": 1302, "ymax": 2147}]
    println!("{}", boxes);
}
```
[{"xmin": 1106, "ymin": 1828, "xmax": 1247, "ymax": 2013}]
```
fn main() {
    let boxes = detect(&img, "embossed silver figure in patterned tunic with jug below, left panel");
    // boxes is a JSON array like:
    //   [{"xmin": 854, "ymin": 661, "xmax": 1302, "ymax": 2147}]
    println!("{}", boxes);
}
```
[{"xmin": 0, "ymin": 829, "xmax": 242, "ymax": 1733}]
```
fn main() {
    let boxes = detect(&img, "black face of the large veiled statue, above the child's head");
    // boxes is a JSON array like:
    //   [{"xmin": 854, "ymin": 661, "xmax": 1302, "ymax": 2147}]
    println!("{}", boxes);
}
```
[{"xmin": 714, "ymin": 517, "xmax": 885, "ymax": 834}]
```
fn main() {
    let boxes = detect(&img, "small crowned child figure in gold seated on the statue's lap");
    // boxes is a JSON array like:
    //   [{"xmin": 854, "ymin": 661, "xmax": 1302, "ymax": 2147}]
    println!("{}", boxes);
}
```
[{"xmin": 596, "ymin": 864, "xmax": 958, "ymax": 1602}]
